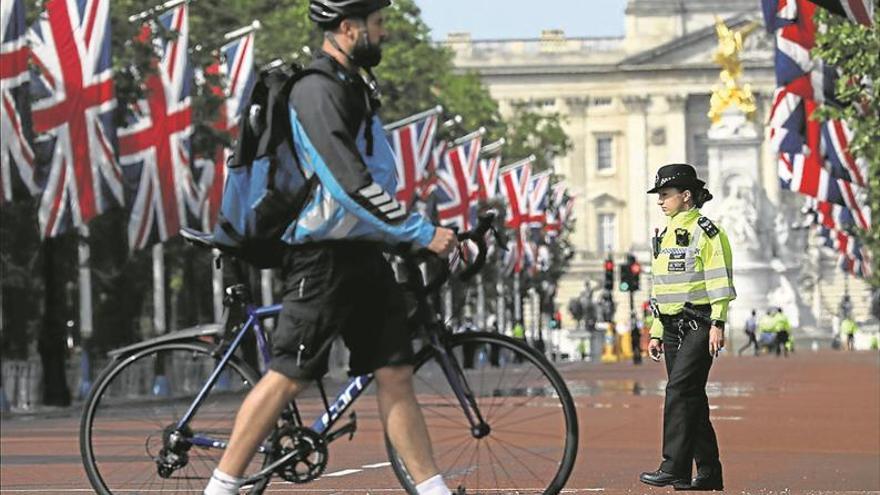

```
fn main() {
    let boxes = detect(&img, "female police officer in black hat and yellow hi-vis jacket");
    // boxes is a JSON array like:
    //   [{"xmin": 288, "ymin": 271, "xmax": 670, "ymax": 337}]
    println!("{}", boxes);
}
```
[{"xmin": 640, "ymin": 164, "xmax": 736, "ymax": 490}]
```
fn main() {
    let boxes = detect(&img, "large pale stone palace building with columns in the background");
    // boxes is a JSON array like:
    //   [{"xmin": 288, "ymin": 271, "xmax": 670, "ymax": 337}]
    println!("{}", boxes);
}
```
[{"xmin": 442, "ymin": 0, "xmax": 868, "ymax": 334}]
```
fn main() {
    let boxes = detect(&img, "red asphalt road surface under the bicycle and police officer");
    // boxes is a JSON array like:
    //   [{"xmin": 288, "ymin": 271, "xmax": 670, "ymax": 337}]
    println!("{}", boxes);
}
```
[{"xmin": 0, "ymin": 351, "xmax": 880, "ymax": 495}]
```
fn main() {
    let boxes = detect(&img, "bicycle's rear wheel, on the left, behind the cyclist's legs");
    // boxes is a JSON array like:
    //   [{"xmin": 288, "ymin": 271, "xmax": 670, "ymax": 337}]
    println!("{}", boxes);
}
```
[{"xmin": 80, "ymin": 342, "xmax": 265, "ymax": 495}]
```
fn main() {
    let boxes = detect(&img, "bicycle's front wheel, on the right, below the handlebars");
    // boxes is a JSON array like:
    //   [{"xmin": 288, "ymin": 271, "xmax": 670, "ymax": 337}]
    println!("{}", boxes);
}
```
[{"xmin": 386, "ymin": 332, "xmax": 578, "ymax": 494}]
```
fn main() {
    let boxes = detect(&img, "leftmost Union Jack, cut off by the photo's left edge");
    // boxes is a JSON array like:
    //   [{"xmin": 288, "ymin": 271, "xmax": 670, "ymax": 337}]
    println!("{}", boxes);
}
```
[{"xmin": 0, "ymin": 0, "xmax": 39, "ymax": 204}]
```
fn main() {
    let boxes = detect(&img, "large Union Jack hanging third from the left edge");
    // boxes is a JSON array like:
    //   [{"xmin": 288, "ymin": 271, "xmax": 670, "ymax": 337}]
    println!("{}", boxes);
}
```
[{"xmin": 119, "ymin": 3, "xmax": 198, "ymax": 250}]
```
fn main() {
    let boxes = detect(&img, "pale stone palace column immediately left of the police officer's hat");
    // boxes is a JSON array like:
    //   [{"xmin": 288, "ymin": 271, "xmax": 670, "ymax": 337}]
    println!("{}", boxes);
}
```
[{"xmin": 619, "ymin": 95, "xmax": 651, "ymax": 251}]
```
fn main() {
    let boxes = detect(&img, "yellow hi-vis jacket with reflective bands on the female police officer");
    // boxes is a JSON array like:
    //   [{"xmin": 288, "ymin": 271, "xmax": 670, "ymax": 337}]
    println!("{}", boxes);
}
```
[{"xmin": 651, "ymin": 208, "xmax": 736, "ymax": 337}]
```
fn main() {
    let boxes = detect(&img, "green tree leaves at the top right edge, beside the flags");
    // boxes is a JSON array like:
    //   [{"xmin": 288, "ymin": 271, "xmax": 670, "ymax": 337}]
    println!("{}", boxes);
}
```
[{"xmin": 812, "ymin": 8, "xmax": 880, "ymax": 287}]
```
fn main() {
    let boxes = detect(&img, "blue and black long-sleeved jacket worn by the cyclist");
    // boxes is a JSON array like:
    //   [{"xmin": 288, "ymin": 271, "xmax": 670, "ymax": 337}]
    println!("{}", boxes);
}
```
[{"xmin": 282, "ymin": 55, "xmax": 435, "ymax": 247}]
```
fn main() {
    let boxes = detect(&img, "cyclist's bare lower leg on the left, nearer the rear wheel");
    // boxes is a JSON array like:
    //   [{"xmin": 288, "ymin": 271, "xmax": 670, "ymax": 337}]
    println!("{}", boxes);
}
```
[{"xmin": 217, "ymin": 370, "xmax": 308, "ymax": 478}]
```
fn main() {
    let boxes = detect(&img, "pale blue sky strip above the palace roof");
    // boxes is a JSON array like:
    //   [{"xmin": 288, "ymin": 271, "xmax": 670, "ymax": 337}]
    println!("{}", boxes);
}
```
[{"xmin": 415, "ymin": 0, "xmax": 626, "ymax": 41}]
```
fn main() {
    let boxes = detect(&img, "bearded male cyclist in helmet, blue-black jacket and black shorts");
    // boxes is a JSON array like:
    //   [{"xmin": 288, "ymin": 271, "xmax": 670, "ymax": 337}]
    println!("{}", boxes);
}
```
[{"xmin": 205, "ymin": 0, "xmax": 456, "ymax": 495}]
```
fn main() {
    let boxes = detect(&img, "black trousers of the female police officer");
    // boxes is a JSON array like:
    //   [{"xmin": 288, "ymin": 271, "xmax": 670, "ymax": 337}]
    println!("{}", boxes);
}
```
[{"xmin": 660, "ymin": 319, "xmax": 721, "ymax": 478}]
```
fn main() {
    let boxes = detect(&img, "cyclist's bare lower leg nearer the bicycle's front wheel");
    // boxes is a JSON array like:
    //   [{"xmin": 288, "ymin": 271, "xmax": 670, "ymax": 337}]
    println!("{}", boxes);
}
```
[{"xmin": 375, "ymin": 366, "xmax": 438, "ymax": 484}]
